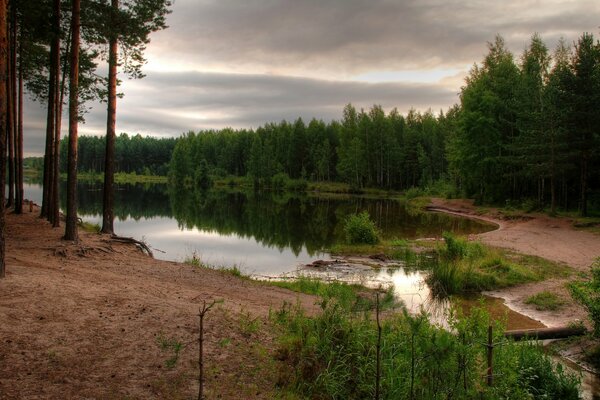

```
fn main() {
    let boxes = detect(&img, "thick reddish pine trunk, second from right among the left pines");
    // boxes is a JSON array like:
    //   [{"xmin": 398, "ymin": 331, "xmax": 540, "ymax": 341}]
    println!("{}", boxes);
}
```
[{"xmin": 65, "ymin": 0, "xmax": 80, "ymax": 241}]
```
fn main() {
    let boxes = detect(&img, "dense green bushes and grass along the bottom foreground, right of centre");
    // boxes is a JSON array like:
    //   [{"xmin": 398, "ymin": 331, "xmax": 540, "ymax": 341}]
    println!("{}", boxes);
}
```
[{"xmin": 271, "ymin": 290, "xmax": 579, "ymax": 400}]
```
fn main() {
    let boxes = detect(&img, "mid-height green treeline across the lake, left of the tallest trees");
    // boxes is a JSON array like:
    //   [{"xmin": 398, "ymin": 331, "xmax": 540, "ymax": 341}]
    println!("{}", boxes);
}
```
[{"xmin": 171, "ymin": 104, "xmax": 447, "ymax": 189}]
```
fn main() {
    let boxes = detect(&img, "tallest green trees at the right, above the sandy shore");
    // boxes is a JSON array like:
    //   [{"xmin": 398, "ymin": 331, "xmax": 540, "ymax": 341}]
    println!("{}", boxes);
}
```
[{"xmin": 446, "ymin": 33, "xmax": 600, "ymax": 215}]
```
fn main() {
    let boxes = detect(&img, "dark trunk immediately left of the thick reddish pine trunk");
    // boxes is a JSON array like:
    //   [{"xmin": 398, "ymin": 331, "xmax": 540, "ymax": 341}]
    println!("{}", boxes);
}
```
[{"xmin": 48, "ymin": 0, "xmax": 61, "ymax": 228}]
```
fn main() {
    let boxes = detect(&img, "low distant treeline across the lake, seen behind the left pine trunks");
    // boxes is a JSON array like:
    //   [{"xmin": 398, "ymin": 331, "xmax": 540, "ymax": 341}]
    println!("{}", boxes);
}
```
[{"xmin": 60, "ymin": 133, "xmax": 177, "ymax": 176}]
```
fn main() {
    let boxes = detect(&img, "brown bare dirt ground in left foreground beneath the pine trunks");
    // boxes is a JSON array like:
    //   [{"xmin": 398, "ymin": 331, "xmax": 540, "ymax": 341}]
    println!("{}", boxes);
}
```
[{"xmin": 0, "ymin": 210, "xmax": 315, "ymax": 399}]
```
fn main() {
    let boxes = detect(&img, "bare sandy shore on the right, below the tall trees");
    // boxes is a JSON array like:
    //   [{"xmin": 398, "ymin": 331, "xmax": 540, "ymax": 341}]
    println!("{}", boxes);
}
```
[{"xmin": 431, "ymin": 199, "xmax": 600, "ymax": 326}]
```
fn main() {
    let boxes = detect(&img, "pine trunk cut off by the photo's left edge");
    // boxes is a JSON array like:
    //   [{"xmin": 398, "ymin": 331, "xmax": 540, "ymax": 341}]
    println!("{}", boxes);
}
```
[{"xmin": 0, "ymin": 0, "xmax": 8, "ymax": 278}]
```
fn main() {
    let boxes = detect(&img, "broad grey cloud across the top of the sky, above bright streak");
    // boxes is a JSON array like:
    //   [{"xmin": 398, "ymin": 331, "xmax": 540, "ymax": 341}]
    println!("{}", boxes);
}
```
[{"xmin": 153, "ymin": 0, "xmax": 600, "ymax": 73}]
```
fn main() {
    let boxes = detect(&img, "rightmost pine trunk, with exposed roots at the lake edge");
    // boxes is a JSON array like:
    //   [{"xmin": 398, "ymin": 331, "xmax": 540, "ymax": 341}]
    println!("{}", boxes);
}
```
[{"xmin": 102, "ymin": 0, "xmax": 119, "ymax": 234}]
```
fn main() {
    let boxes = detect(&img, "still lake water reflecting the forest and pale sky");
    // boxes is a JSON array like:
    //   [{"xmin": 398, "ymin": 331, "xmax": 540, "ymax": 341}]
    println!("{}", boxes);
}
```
[{"xmin": 25, "ymin": 184, "xmax": 494, "ymax": 277}]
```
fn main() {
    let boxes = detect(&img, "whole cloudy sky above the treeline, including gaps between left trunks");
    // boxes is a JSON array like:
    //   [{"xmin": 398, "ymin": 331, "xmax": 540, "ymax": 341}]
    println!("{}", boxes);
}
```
[{"xmin": 25, "ymin": 0, "xmax": 600, "ymax": 155}]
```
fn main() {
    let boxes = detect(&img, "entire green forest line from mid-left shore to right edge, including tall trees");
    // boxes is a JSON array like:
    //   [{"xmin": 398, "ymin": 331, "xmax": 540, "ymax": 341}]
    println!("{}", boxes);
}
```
[{"xmin": 170, "ymin": 33, "xmax": 600, "ymax": 215}]
